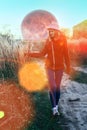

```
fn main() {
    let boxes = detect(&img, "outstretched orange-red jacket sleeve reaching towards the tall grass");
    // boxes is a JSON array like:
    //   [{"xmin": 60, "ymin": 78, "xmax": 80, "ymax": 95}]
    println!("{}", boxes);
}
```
[{"xmin": 27, "ymin": 41, "xmax": 47, "ymax": 58}]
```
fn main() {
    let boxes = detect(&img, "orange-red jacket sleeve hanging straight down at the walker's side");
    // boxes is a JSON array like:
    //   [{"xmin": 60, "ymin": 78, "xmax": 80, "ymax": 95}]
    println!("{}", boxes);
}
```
[{"xmin": 64, "ymin": 38, "xmax": 70, "ymax": 70}]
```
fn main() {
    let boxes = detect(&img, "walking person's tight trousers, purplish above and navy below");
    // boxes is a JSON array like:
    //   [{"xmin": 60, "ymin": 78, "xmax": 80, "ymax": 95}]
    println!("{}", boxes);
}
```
[{"xmin": 47, "ymin": 69, "xmax": 63, "ymax": 107}]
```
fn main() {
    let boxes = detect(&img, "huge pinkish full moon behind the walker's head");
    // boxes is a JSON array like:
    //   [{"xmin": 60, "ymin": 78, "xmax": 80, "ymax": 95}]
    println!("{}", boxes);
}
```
[{"xmin": 21, "ymin": 10, "xmax": 58, "ymax": 41}]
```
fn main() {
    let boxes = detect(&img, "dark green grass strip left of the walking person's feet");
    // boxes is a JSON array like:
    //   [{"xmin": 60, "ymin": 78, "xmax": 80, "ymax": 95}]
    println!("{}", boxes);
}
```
[{"xmin": 24, "ymin": 90, "xmax": 62, "ymax": 130}]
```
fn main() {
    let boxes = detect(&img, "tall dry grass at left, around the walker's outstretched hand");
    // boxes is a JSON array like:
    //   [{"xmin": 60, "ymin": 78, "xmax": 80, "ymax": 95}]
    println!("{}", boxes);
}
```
[{"xmin": 0, "ymin": 34, "xmax": 44, "ymax": 79}]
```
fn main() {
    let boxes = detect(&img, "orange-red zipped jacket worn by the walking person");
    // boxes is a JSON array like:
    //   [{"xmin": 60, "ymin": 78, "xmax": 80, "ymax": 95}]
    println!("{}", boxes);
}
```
[{"xmin": 29, "ymin": 32, "xmax": 70, "ymax": 70}]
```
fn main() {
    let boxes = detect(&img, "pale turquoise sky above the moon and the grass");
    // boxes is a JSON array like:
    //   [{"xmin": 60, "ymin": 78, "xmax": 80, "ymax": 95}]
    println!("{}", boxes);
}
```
[{"xmin": 0, "ymin": 0, "xmax": 87, "ymax": 37}]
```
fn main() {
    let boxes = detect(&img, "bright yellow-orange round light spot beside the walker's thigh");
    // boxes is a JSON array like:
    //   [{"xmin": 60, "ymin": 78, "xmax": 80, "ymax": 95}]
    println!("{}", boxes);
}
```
[{"xmin": 18, "ymin": 62, "xmax": 47, "ymax": 91}]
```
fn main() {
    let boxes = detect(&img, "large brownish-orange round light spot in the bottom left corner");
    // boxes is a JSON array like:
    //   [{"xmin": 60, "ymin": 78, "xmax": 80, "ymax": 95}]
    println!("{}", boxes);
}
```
[{"xmin": 0, "ymin": 81, "xmax": 34, "ymax": 130}]
